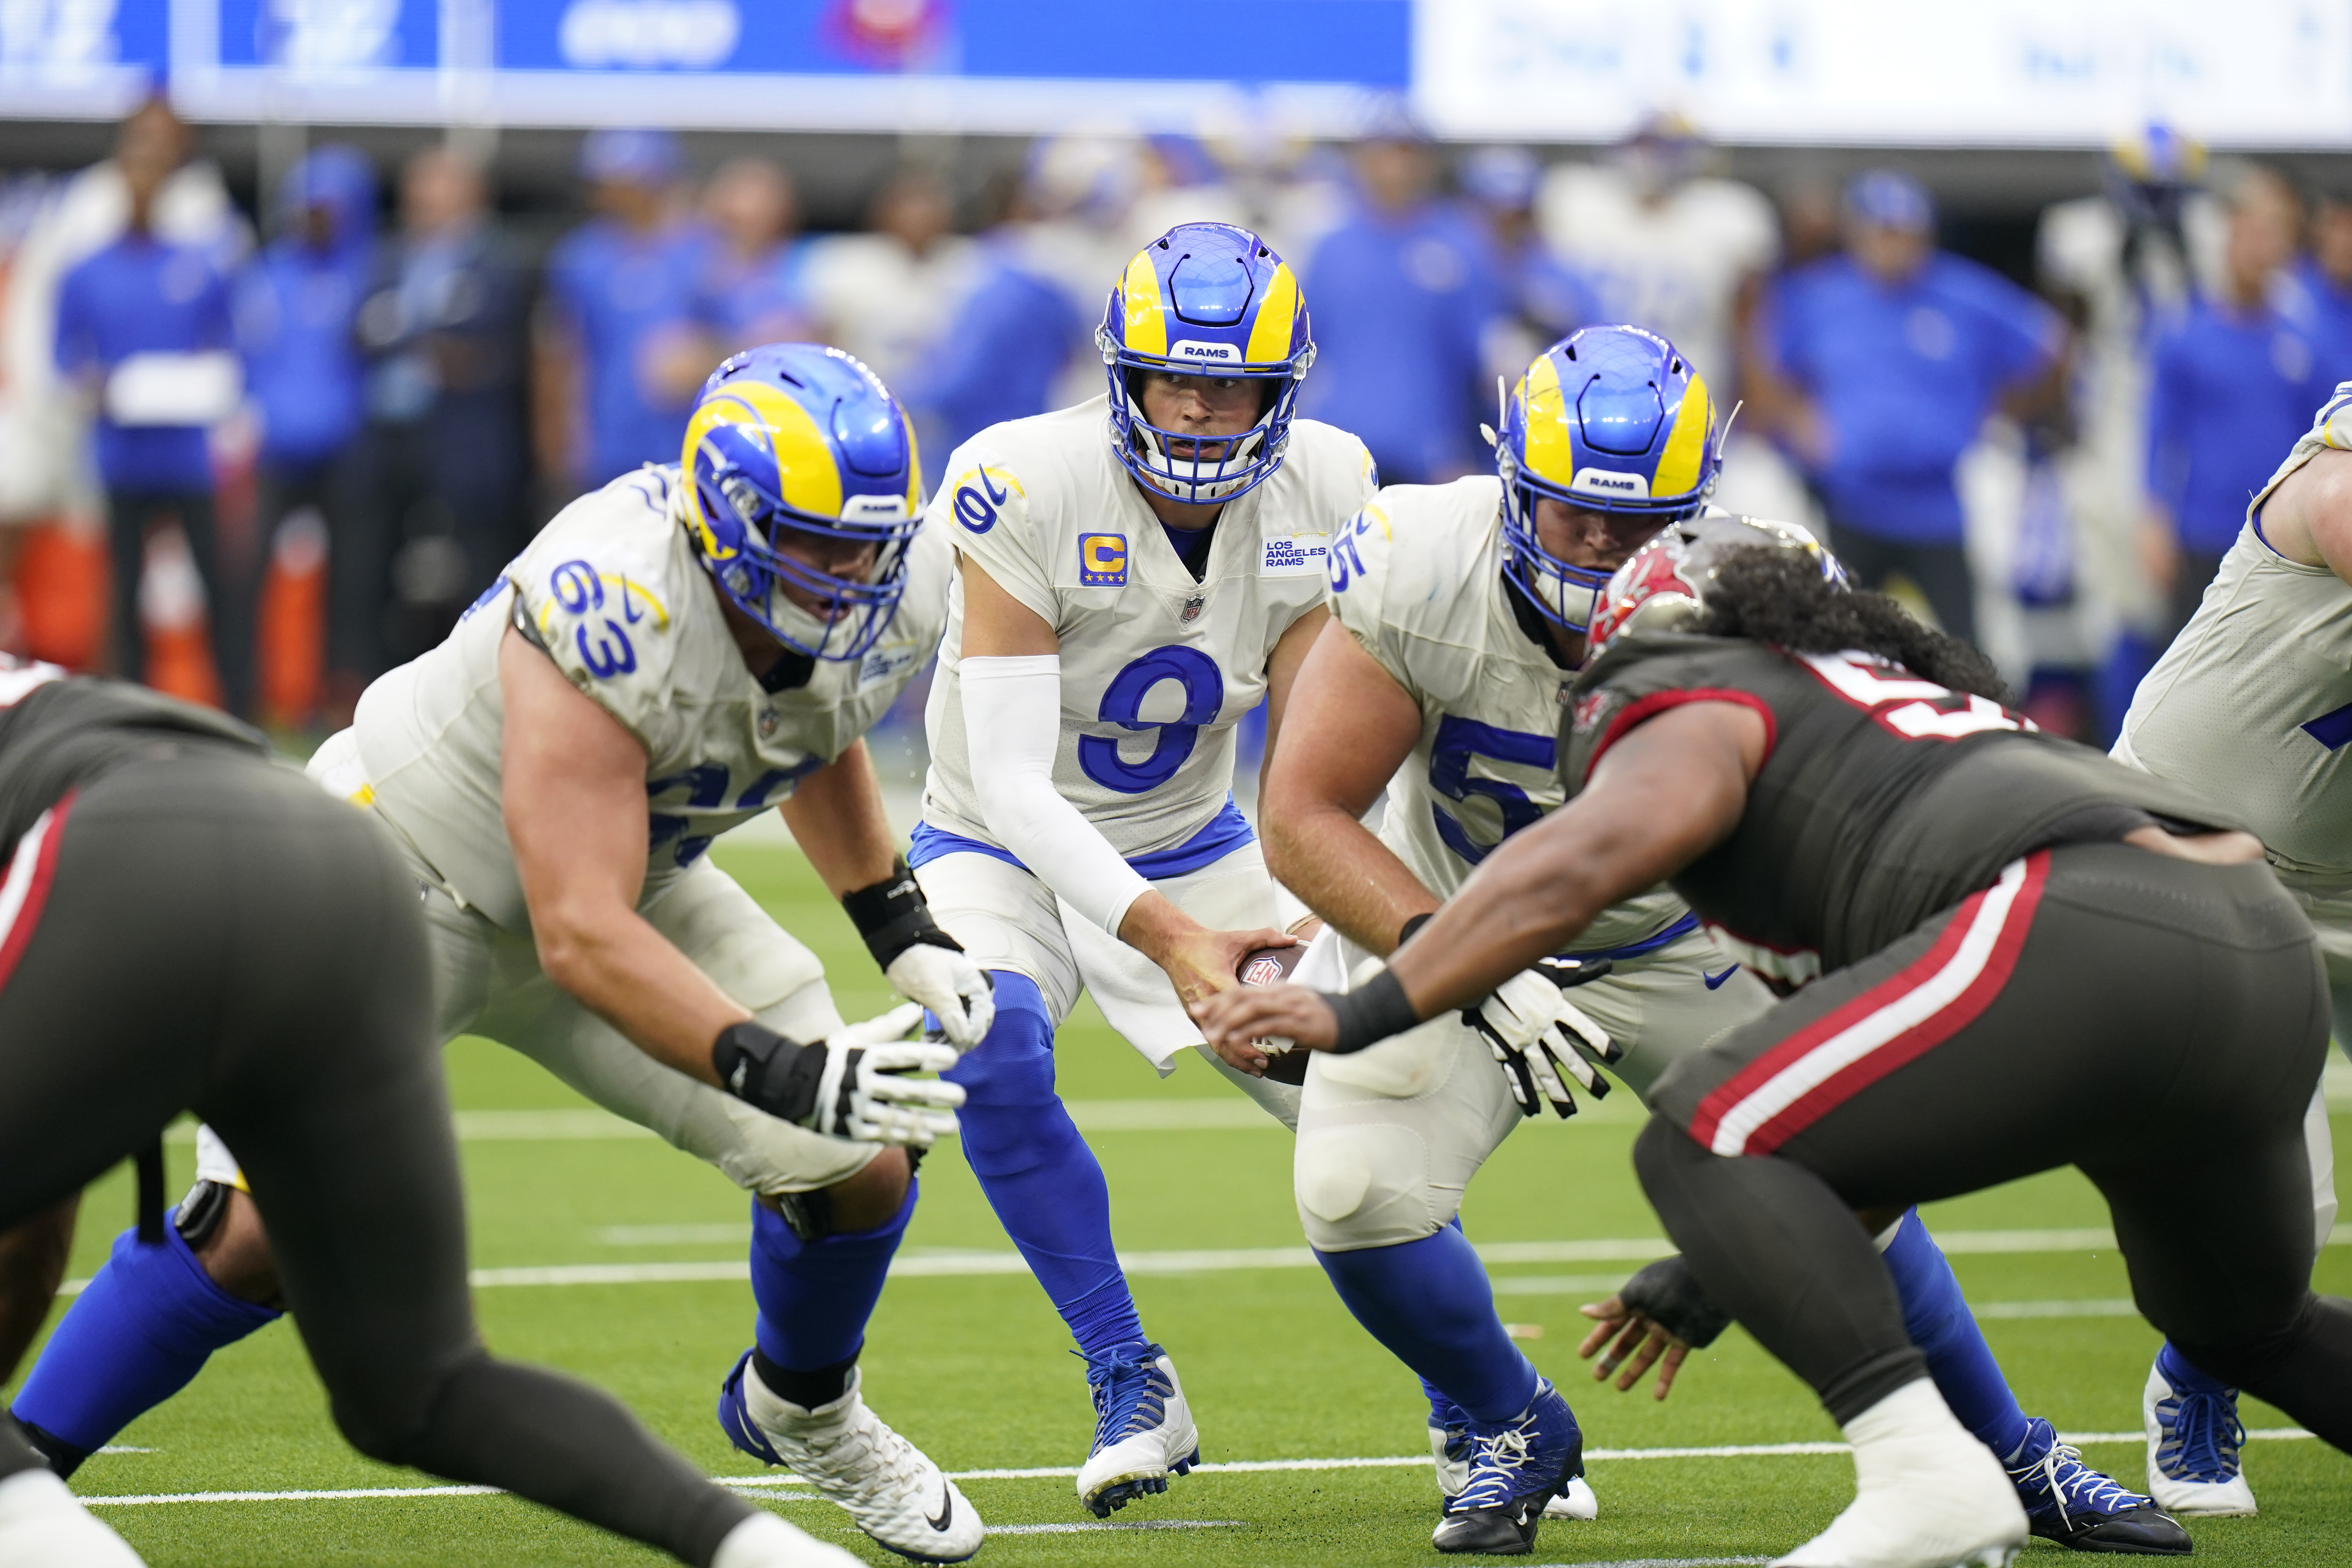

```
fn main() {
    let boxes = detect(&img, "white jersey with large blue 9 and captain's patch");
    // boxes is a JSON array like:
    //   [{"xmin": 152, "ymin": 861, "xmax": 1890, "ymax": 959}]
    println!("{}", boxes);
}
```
[{"xmin": 922, "ymin": 397, "xmax": 1371, "ymax": 858}]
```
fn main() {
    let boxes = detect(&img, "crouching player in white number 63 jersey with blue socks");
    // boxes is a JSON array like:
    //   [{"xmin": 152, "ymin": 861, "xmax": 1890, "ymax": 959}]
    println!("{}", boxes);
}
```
[{"xmin": 14, "ymin": 343, "xmax": 990, "ymax": 1561}]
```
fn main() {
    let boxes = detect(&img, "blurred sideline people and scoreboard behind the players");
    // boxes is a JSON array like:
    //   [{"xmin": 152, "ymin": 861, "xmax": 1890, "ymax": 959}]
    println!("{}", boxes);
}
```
[{"xmin": 0, "ymin": 0, "xmax": 2352, "ymax": 808}]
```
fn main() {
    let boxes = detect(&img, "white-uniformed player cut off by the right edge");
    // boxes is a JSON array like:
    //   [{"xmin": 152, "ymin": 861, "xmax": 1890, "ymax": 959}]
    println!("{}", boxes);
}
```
[{"xmin": 2114, "ymin": 383, "xmax": 2352, "ymax": 1514}]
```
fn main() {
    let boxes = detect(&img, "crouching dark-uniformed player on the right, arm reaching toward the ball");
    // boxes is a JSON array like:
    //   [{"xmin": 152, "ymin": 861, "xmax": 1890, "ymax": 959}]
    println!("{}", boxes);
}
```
[{"xmin": 1197, "ymin": 517, "xmax": 2352, "ymax": 1568}]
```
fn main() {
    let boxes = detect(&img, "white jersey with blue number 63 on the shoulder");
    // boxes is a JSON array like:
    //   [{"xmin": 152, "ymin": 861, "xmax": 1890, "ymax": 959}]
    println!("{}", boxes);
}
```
[{"xmin": 353, "ymin": 468, "xmax": 955, "ymax": 931}]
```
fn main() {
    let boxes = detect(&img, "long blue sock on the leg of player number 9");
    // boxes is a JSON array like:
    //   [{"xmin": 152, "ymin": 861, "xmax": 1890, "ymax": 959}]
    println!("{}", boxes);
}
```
[{"xmin": 943, "ymin": 969, "xmax": 1143, "ymax": 1356}]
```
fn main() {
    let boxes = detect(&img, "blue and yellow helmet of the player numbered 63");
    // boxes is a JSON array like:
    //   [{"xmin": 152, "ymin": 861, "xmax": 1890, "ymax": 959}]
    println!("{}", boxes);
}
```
[{"xmin": 680, "ymin": 343, "xmax": 922, "ymax": 658}]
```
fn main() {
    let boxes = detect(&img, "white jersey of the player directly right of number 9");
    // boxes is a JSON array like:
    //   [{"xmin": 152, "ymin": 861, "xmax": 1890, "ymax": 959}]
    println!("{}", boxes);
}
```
[{"xmin": 1331, "ymin": 475, "xmax": 1689, "ymax": 952}]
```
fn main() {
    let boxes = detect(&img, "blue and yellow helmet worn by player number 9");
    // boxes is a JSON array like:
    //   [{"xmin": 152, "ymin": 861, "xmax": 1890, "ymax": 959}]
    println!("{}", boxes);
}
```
[{"xmin": 1094, "ymin": 223, "xmax": 1315, "ymax": 503}]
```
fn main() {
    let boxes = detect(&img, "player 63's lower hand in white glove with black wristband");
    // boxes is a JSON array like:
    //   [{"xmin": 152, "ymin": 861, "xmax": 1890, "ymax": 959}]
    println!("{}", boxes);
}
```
[{"xmin": 710, "ymin": 1002, "xmax": 964, "ymax": 1150}]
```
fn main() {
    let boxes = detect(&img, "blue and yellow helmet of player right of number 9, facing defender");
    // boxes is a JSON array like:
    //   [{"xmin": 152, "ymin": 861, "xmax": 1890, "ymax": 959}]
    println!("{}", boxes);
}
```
[{"xmin": 1494, "ymin": 327, "xmax": 1722, "ymax": 632}]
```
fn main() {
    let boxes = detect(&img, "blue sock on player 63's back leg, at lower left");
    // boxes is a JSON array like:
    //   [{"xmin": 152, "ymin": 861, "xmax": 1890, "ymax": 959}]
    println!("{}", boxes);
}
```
[{"xmin": 12, "ymin": 1210, "xmax": 280, "ymax": 1453}]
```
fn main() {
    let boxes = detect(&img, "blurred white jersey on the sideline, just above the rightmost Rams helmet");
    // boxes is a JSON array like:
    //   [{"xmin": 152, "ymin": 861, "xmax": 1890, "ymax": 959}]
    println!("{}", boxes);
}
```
[{"xmin": 1536, "ymin": 162, "xmax": 1780, "ymax": 388}]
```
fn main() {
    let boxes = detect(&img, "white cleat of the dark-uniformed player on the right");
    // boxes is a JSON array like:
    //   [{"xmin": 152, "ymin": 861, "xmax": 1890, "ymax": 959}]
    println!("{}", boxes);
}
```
[{"xmin": 1773, "ymin": 1377, "xmax": 2027, "ymax": 1568}]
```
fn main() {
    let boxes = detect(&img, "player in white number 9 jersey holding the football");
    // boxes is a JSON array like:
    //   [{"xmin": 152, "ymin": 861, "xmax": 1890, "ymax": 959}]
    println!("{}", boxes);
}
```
[{"xmin": 910, "ymin": 223, "xmax": 1374, "ymax": 1516}]
